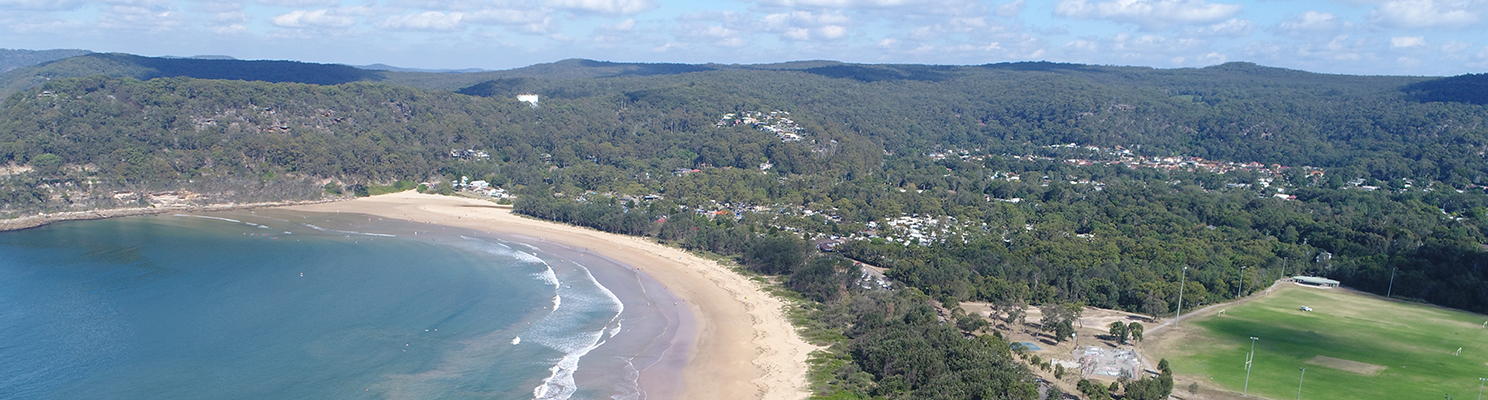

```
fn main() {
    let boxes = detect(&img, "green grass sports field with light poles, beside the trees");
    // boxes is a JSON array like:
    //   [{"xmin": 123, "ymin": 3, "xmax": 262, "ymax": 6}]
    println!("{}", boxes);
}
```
[{"xmin": 1147, "ymin": 284, "xmax": 1488, "ymax": 400}]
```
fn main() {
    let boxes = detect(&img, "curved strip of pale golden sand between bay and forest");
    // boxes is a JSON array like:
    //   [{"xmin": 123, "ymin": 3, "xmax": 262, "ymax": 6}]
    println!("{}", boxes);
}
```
[{"xmin": 287, "ymin": 192, "xmax": 817, "ymax": 400}]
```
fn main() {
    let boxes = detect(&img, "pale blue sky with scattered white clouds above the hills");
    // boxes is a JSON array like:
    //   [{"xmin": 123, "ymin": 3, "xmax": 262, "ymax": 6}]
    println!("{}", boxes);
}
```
[{"xmin": 0, "ymin": 0, "xmax": 1488, "ymax": 76}]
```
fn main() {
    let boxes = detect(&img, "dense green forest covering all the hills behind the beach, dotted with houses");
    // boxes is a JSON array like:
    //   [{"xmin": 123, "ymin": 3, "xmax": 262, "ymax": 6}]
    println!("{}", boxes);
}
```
[{"xmin": 0, "ymin": 55, "xmax": 1488, "ymax": 399}]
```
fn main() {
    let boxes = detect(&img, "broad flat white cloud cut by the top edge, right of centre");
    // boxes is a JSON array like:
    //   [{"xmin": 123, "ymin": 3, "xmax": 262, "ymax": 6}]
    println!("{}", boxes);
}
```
[{"xmin": 1054, "ymin": 0, "xmax": 1242, "ymax": 28}]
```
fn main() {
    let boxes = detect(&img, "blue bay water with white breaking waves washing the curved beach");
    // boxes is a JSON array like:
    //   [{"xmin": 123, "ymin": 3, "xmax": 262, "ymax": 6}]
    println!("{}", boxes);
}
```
[{"xmin": 0, "ymin": 210, "xmax": 690, "ymax": 399}]
